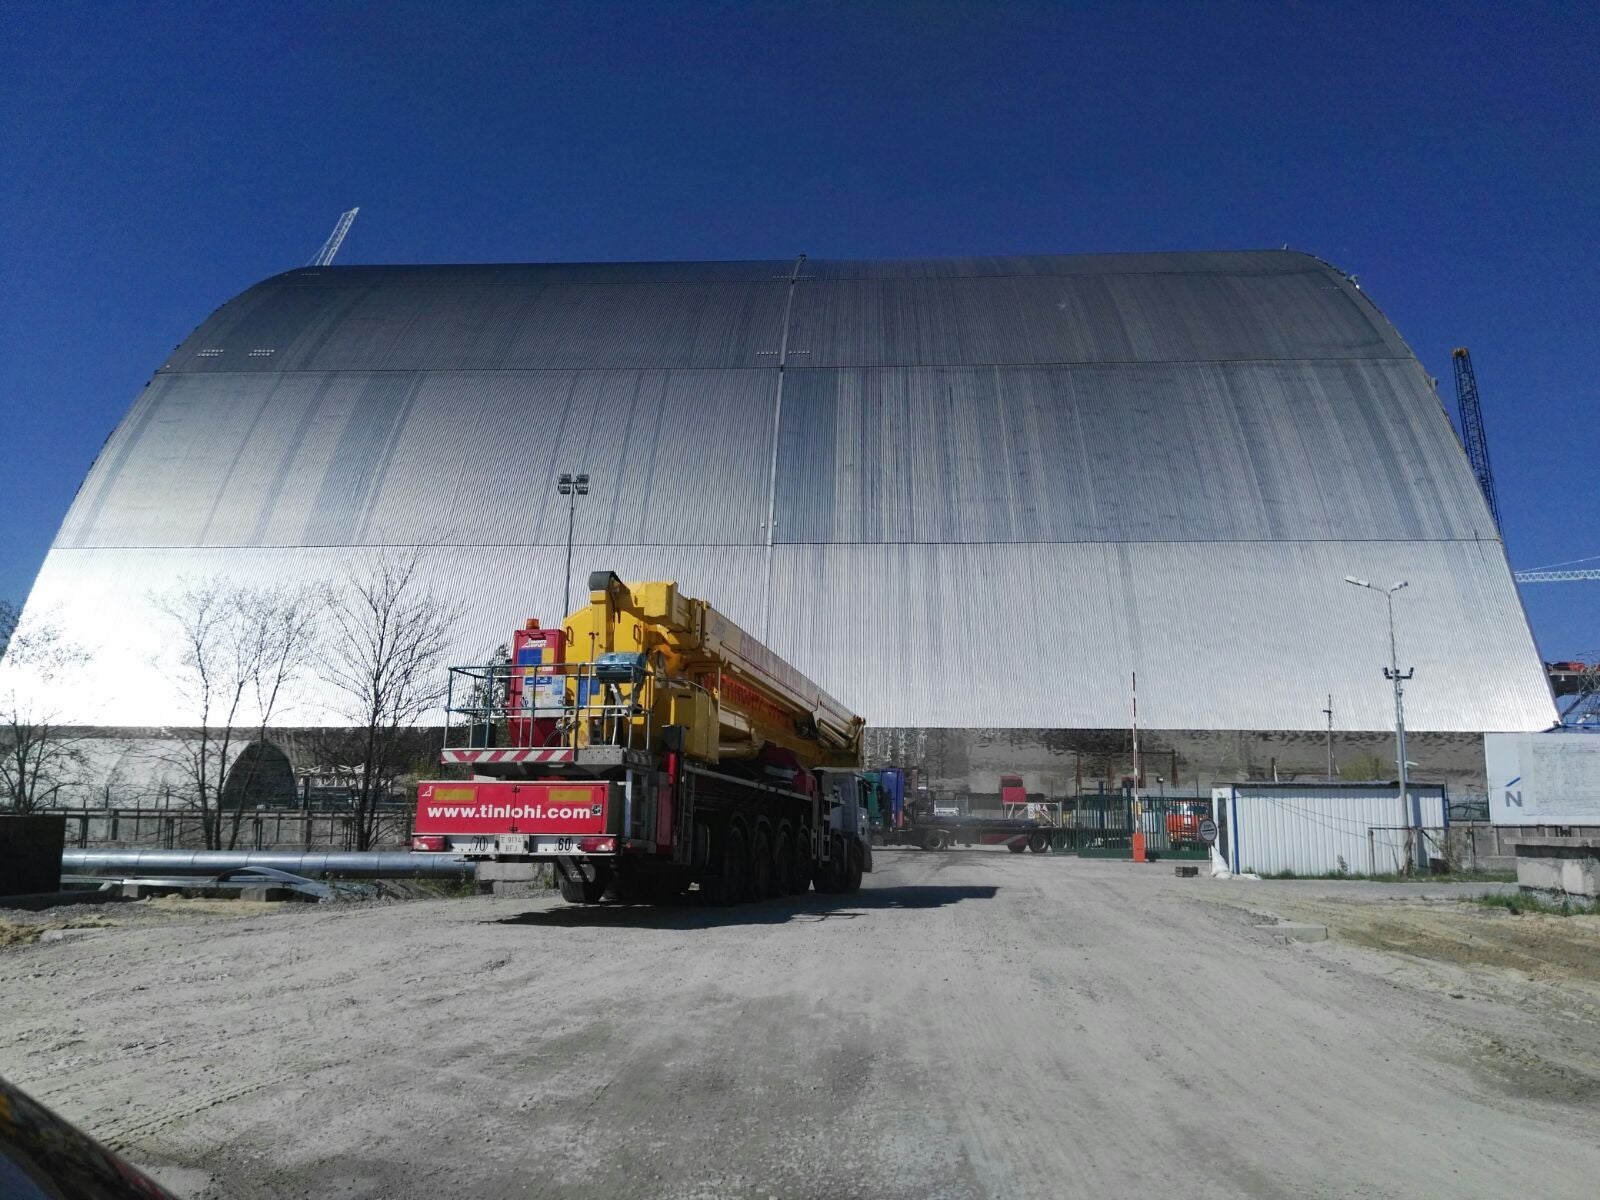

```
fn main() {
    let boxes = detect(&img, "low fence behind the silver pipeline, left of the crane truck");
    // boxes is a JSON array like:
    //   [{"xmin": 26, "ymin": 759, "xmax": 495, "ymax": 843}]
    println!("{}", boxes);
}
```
[{"xmin": 66, "ymin": 806, "xmax": 414, "ymax": 850}]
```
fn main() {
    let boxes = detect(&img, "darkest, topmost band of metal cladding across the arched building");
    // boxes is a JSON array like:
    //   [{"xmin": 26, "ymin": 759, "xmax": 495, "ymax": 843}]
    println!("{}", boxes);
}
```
[{"xmin": 163, "ymin": 251, "xmax": 1388, "ymax": 373}]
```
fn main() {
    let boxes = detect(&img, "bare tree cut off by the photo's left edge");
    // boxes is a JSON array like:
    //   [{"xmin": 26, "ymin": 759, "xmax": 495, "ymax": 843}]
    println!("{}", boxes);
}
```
[{"xmin": 0, "ymin": 603, "xmax": 88, "ymax": 813}]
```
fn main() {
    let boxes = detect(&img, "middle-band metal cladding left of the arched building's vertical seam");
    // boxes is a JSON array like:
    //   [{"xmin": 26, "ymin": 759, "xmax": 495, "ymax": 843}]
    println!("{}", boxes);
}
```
[{"xmin": 58, "ymin": 371, "xmax": 776, "ymax": 546}]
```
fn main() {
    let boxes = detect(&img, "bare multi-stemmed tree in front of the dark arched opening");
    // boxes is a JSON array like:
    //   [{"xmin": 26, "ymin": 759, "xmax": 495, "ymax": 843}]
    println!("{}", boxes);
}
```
[{"xmin": 152, "ymin": 576, "xmax": 323, "ymax": 850}]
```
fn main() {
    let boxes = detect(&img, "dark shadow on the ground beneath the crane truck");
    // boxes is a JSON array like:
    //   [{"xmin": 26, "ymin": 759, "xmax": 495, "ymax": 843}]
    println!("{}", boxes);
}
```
[{"xmin": 483, "ymin": 883, "xmax": 998, "ymax": 930}]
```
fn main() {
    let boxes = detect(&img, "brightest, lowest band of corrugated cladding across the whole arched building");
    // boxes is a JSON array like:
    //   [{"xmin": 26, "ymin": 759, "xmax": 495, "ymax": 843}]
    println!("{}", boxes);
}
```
[{"xmin": 18, "ymin": 542, "xmax": 1549, "ymax": 731}]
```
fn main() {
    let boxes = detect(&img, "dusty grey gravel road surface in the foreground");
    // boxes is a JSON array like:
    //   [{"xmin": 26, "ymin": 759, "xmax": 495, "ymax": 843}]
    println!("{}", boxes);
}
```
[{"xmin": 0, "ymin": 851, "xmax": 1600, "ymax": 1200}]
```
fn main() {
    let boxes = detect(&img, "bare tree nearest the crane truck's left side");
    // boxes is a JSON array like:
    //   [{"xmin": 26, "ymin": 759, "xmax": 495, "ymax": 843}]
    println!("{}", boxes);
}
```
[{"xmin": 323, "ymin": 552, "xmax": 458, "ymax": 850}]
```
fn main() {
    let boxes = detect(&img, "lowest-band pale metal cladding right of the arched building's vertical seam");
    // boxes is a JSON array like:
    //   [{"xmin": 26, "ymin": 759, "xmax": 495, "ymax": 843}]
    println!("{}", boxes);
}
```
[{"xmin": 768, "ymin": 542, "xmax": 1552, "ymax": 731}]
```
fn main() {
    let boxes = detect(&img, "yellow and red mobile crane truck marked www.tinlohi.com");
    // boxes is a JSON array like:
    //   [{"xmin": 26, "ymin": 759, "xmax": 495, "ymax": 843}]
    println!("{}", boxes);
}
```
[{"xmin": 411, "ymin": 571, "xmax": 872, "ymax": 904}]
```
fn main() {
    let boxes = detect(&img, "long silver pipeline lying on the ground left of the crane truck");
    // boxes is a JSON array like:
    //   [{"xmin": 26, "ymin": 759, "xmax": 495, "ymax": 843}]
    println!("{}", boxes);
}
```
[{"xmin": 61, "ymin": 850, "xmax": 475, "ymax": 878}]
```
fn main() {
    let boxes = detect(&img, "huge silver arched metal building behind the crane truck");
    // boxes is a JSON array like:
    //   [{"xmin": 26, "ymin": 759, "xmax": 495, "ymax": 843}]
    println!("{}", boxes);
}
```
[{"xmin": 3, "ymin": 251, "xmax": 1555, "ymax": 795}]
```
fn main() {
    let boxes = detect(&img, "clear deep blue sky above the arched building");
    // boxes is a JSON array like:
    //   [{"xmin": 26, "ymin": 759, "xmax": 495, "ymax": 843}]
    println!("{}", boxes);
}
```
[{"xmin": 0, "ymin": 0, "xmax": 1600, "ymax": 658}]
